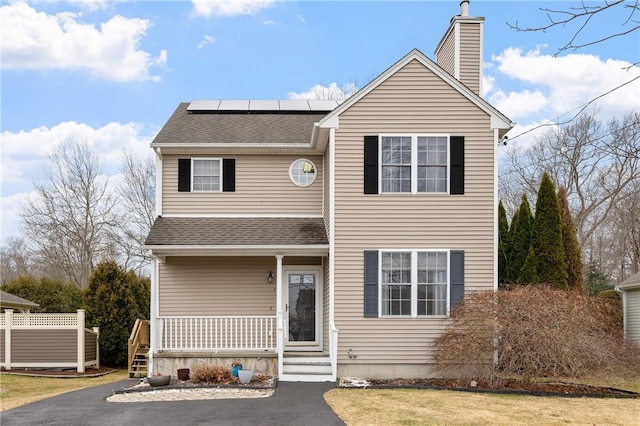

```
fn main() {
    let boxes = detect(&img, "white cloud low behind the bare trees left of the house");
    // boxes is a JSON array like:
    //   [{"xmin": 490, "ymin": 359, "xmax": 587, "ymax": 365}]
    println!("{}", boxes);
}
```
[{"xmin": 0, "ymin": 121, "xmax": 153, "ymax": 240}]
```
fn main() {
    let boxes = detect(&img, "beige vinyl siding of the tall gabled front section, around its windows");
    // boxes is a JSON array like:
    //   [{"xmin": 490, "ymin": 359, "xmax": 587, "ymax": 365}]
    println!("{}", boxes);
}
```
[{"xmin": 335, "ymin": 61, "xmax": 494, "ymax": 365}]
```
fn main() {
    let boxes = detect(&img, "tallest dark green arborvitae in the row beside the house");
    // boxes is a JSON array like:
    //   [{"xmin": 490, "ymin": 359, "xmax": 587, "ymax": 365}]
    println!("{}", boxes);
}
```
[{"xmin": 531, "ymin": 173, "xmax": 568, "ymax": 290}]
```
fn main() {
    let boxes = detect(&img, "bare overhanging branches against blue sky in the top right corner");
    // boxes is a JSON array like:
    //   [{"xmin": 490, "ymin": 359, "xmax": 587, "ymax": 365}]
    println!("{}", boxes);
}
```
[{"xmin": 507, "ymin": 0, "xmax": 640, "ymax": 65}]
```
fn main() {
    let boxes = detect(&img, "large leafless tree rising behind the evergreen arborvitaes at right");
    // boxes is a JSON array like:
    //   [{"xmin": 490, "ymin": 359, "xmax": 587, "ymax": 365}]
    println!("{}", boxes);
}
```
[{"xmin": 500, "ymin": 112, "xmax": 640, "ymax": 279}]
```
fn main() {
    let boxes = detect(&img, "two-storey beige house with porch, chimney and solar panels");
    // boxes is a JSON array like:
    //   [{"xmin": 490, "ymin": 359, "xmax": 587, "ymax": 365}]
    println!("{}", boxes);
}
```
[{"xmin": 146, "ymin": 1, "xmax": 513, "ymax": 381}]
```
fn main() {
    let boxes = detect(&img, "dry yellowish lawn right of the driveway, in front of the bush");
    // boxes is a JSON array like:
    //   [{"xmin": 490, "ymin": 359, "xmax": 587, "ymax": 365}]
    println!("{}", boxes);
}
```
[{"xmin": 325, "ymin": 378, "xmax": 640, "ymax": 426}]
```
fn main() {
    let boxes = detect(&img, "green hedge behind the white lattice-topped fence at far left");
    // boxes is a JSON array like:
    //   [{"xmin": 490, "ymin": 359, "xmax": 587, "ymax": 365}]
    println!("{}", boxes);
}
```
[{"xmin": 2, "ymin": 275, "xmax": 82, "ymax": 313}]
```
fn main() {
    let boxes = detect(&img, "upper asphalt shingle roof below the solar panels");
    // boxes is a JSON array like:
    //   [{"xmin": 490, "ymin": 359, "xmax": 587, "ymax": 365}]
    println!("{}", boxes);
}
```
[{"xmin": 153, "ymin": 102, "xmax": 326, "ymax": 144}]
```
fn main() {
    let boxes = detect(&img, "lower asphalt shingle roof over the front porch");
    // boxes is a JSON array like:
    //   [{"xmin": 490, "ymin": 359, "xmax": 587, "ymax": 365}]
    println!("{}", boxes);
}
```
[{"xmin": 145, "ymin": 217, "xmax": 329, "ymax": 246}]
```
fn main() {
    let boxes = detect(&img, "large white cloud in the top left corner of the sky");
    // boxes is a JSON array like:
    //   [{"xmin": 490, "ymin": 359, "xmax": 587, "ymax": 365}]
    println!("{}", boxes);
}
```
[{"xmin": 0, "ymin": 2, "xmax": 167, "ymax": 81}]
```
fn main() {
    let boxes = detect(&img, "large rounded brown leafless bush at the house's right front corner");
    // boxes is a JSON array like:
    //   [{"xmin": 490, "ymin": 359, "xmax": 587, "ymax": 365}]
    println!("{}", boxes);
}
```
[{"xmin": 434, "ymin": 285, "xmax": 640, "ymax": 381}]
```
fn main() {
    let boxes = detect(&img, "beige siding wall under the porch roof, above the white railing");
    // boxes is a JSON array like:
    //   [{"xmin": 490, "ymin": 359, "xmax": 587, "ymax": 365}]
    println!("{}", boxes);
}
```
[{"xmin": 159, "ymin": 257, "xmax": 277, "ymax": 316}]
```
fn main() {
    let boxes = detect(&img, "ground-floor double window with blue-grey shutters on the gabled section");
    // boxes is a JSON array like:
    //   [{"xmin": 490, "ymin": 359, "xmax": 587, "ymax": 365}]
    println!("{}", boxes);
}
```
[{"xmin": 363, "ymin": 250, "xmax": 465, "ymax": 318}]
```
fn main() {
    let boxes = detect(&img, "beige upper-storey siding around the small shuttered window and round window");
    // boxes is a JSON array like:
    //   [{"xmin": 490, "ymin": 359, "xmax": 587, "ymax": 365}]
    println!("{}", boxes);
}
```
[{"xmin": 162, "ymin": 155, "xmax": 323, "ymax": 216}]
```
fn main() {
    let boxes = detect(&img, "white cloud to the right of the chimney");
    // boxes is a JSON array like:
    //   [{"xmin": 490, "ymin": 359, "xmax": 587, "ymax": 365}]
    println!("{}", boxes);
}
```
[{"xmin": 489, "ymin": 48, "xmax": 640, "ymax": 119}]
